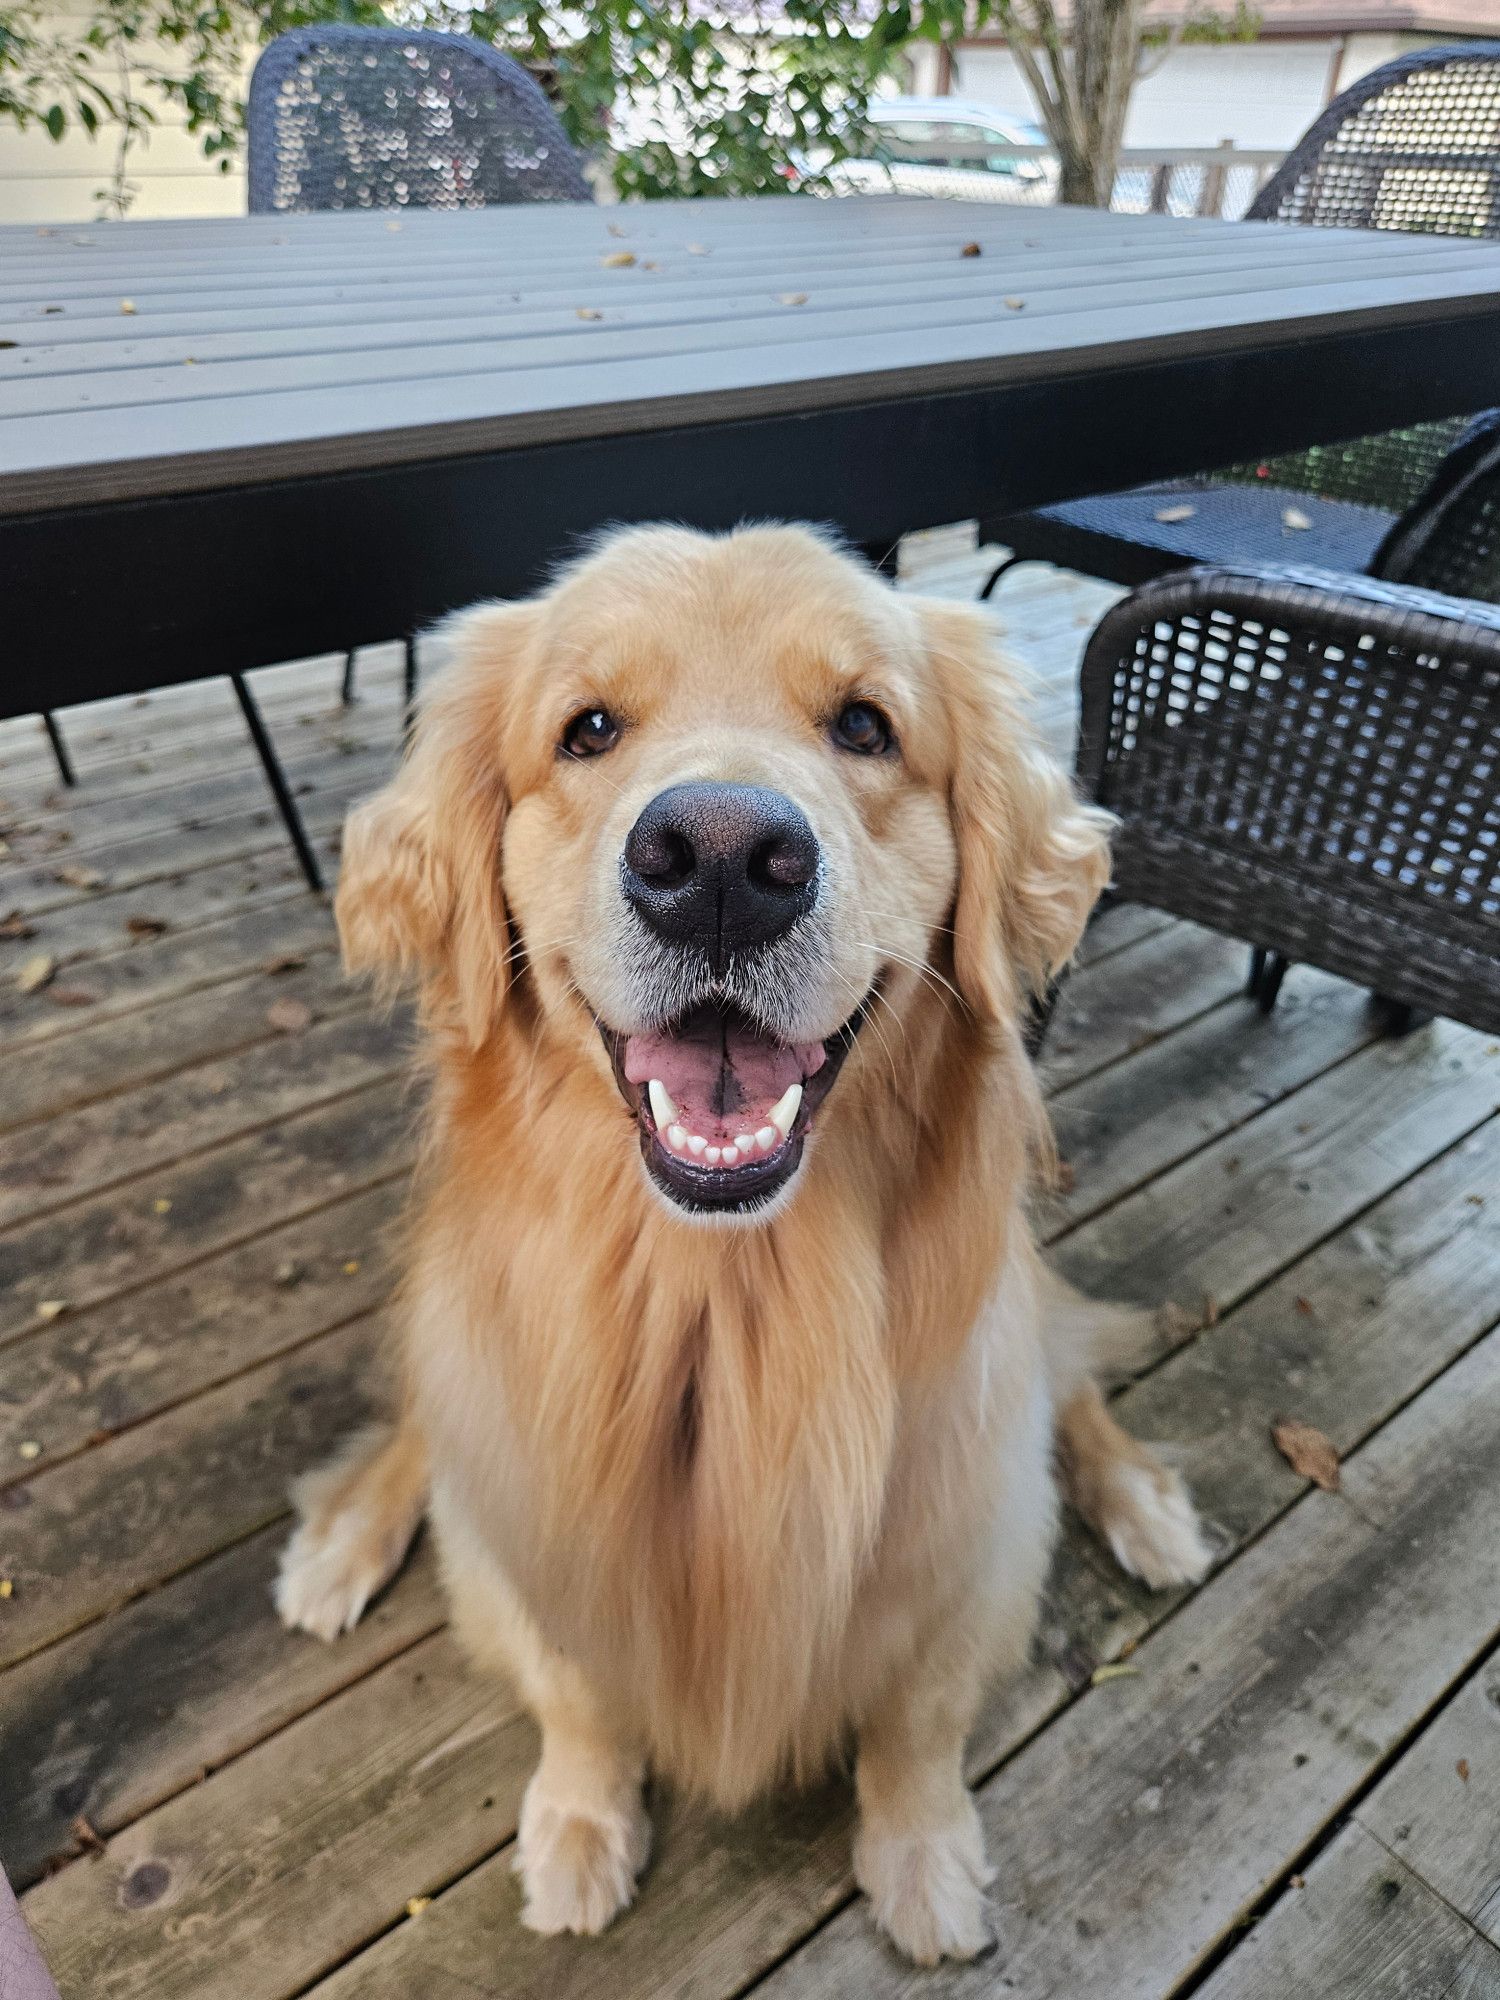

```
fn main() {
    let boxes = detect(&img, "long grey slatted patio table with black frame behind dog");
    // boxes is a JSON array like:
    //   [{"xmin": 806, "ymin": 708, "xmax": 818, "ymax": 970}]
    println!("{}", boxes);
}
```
[{"xmin": 0, "ymin": 198, "xmax": 1500, "ymax": 714}]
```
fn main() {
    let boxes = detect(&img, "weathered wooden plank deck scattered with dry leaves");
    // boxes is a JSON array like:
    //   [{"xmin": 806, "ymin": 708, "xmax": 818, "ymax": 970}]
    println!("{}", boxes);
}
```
[{"xmin": 0, "ymin": 552, "xmax": 1500, "ymax": 2000}]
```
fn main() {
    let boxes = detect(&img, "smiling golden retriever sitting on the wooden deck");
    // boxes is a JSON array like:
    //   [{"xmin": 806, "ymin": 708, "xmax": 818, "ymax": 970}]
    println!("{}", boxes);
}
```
[{"xmin": 278, "ymin": 526, "xmax": 1208, "ymax": 1962}]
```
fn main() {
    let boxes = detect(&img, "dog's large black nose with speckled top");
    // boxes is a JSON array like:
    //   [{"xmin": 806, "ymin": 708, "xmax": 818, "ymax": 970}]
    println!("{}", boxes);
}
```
[{"xmin": 624, "ymin": 784, "xmax": 818, "ymax": 972}]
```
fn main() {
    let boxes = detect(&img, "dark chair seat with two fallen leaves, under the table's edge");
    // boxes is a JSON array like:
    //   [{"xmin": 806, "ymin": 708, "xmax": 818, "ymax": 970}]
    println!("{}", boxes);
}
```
[{"xmin": 984, "ymin": 480, "xmax": 1394, "ymax": 584}]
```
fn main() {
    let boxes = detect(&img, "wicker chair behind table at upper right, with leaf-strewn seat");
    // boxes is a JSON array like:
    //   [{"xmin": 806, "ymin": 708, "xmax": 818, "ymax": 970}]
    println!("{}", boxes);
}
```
[{"xmin": 980, "ymin": 42, "xmax": 1500, "ymax": 598}]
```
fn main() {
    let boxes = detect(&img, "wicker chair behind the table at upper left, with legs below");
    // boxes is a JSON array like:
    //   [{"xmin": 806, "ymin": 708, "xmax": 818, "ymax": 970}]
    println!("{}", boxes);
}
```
[{"xmin": 232, "ymin": 24, "xmax": 594, "ymax": 888}]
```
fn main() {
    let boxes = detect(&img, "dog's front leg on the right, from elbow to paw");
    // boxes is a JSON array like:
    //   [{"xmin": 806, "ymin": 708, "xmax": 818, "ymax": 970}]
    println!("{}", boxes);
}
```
[{"xmin": 854, "ymin": 1626, "xmax": 994, "ymax": 1966}]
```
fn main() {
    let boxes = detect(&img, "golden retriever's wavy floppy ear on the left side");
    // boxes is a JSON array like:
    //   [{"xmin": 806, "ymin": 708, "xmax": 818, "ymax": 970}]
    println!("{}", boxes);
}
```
[{"xmin": 334, "ymin": 604, "xmax": 532, "ymax": 1048}]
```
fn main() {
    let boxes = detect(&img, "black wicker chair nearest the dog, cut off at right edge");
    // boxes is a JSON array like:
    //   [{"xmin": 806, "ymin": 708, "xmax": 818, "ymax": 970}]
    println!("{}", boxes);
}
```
[{"xmin": 1078, "ymin": 422, "xmax": 1500, "ymax": 1034}]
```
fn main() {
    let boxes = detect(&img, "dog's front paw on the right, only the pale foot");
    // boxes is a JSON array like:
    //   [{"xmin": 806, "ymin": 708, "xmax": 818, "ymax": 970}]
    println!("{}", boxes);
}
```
[{"xmin": 854, "ymin": 1800, "xmax": 994, "ymax": 1966}]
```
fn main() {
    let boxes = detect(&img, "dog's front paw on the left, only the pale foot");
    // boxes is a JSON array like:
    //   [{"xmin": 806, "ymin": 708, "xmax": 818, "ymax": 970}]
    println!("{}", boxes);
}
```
[{"xmin": 514, "ymin": 1778, "xmax": 652, "ymax": 1938}]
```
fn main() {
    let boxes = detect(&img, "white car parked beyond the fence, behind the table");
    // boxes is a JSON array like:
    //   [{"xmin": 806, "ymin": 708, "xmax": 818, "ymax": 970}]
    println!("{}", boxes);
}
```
[{"xmin": 802, "ymin": 98, "xmax": 1058, "ymax": 202}]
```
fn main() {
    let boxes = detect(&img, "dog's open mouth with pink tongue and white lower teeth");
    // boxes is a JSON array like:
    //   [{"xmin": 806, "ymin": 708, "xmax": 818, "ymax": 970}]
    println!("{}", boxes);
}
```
[{"xmin": 602, "ymin": 996, "xmax": 872, "ymax": 1210}]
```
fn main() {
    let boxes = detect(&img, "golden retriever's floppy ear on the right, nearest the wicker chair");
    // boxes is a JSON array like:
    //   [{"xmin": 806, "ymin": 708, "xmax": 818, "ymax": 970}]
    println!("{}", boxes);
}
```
[{"xmin": 920, "ymin": 602, "xmax": 1112, "ymax": 1022}]
